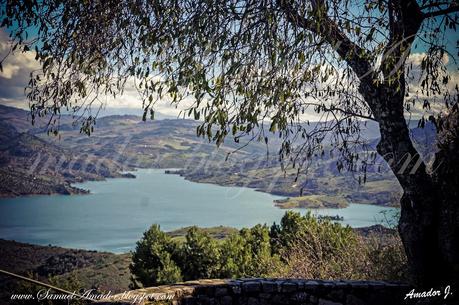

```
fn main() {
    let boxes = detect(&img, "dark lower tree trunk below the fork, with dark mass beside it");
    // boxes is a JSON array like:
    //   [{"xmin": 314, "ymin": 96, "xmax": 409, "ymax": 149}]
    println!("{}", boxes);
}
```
[{"xmin": 360, "ymin": 84, "xmax": 459, "ymax": 288}]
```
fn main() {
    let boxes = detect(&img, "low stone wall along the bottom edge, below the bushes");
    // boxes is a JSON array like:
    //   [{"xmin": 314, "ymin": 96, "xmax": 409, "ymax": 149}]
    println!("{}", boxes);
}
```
[{"xmin": 100, "ymin": 278, "xmax": 409, "ymax": 305}]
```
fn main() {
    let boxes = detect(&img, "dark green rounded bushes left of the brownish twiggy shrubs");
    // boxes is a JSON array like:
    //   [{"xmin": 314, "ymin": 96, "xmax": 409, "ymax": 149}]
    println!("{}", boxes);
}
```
[{"xmin": 130, "ymin": 225, "xmax": 280, "ymax": 287}]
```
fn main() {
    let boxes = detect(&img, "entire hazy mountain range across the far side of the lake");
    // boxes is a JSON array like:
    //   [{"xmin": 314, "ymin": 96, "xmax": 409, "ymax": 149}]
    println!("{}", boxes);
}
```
[{"xmin": 0, "ymin": 105, "xmax": 435, "ymax": 205}]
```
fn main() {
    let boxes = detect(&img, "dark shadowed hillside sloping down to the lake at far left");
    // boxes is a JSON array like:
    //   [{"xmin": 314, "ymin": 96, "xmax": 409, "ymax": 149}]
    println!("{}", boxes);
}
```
[{"xmin": 0, "ymin": 116, "xmax": 133, "ymax": 197}]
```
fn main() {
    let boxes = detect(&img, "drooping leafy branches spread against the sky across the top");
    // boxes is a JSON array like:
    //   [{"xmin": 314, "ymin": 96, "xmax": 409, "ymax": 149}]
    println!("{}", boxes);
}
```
[{"xmin": 1, "ymin": 0, "xmax": 458, "ymax": 176}]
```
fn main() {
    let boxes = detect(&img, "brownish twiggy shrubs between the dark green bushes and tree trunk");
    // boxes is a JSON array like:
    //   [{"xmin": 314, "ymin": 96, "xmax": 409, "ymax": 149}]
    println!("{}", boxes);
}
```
[{"xmin": 271, "ymin": 212, "xmax": 407, "ymax": 281}]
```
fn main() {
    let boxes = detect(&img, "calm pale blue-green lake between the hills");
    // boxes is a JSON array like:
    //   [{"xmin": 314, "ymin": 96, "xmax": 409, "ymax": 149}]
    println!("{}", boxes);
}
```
[{"xmin": 0, "ymin": 169, "xmax": 397, "ymax": 253}]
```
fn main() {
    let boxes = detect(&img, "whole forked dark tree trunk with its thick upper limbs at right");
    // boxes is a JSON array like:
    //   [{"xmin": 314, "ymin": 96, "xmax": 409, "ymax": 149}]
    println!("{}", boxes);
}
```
[{"xmin": 278, "ymin": 0, "xmax": 459, "ymax": 288}]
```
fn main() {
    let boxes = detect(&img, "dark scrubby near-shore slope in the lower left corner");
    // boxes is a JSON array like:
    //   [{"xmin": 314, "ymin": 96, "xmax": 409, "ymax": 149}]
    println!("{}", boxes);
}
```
[{"xmin": 0, "ymin": 239, "xmax": 131, "ymax": 304}]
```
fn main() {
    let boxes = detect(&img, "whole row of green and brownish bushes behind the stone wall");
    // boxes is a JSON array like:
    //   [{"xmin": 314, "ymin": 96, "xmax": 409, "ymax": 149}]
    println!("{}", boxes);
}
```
[{"xmin": 130, "ymin": 211, "xmax": 406, "ymax": 287}]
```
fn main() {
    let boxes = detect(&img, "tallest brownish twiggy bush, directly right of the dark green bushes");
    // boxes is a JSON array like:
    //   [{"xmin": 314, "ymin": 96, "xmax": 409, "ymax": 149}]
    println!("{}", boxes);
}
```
[{"xmin": 271, "ymin": 212, "xmax": 365, "ymax": 279}]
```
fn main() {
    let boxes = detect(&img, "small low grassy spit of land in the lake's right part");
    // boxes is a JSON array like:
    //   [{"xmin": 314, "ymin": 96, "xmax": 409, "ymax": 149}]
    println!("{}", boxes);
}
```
[{"xmin": 274, "ymin": 195, "xmax": 349, "ymax": 209}]
